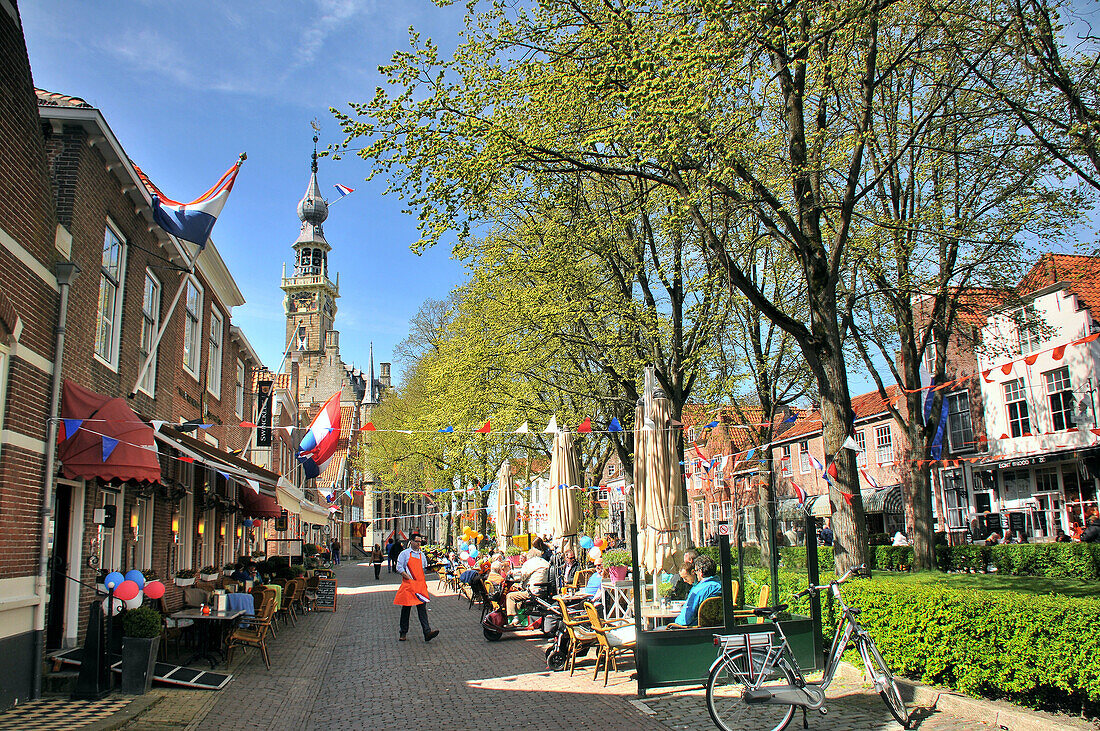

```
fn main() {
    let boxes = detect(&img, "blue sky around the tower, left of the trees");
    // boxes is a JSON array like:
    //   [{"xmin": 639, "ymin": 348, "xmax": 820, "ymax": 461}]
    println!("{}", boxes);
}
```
[{"xmin": 19, "ymin": 0, "xmax": 463, "ymax": 376}]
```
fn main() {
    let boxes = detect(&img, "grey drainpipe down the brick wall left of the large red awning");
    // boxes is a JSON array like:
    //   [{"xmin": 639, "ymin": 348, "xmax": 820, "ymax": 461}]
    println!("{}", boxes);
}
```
[{"xmin": 32, "ymin": 262, "xmax": 80, "ymax": 698}]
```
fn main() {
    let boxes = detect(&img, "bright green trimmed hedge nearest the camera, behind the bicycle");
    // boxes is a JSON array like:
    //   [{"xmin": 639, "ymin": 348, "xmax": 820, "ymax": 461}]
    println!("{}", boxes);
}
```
[{"xmin": 823, "ymin": 576, "xmax": 1100, "ymax": 716}]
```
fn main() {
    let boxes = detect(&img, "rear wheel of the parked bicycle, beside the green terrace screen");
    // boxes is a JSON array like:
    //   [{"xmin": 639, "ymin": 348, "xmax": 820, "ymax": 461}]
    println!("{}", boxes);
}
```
[{"xmin": 706, "ymin": 652, "xmax": 794, "ymax": 731}]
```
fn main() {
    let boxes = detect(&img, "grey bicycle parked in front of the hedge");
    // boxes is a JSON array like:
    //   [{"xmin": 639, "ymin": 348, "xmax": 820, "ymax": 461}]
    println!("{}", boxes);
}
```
[{"xmin": 706, "ymin": 566, "xmax": 909, "ymax": 731}]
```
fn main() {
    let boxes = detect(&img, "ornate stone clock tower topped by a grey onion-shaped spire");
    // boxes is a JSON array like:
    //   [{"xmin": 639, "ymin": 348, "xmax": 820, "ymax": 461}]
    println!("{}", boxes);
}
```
[{"xmin": 283, "ymin": 135, "xmax": 340, "ymax": 359}]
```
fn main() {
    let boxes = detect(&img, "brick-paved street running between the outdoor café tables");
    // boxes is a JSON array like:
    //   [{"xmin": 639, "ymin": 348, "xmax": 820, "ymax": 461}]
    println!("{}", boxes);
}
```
[{"xmin": 121, "ymin": 563, "xmax": 1086, "ymax": 731}]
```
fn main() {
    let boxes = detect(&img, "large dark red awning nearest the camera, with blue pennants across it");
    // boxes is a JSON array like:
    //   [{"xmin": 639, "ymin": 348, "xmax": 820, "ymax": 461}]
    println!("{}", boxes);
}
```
[{"xmin": 57, "ymin": 380, "xmax": 161, "ymax": 483}]
